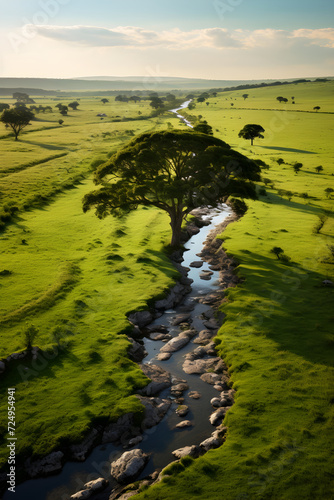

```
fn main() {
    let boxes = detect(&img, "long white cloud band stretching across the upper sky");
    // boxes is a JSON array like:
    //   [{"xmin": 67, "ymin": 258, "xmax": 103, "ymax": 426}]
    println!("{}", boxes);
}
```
[{"xmin": 26, "ymin": 25, "xmax": 334, "ymax": 50}]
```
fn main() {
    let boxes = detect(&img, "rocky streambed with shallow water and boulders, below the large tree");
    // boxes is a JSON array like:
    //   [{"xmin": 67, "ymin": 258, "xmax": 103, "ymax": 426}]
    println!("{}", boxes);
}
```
[{"xmin": 4, "ymin": 206, "xmax": 237, "ymax": 500}]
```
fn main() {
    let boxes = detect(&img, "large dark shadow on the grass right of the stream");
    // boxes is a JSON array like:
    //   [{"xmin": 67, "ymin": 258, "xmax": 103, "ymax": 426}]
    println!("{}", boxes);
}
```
[{"xmin": 230, "ymin": 254, "xmax": 334, "ymax": 367}]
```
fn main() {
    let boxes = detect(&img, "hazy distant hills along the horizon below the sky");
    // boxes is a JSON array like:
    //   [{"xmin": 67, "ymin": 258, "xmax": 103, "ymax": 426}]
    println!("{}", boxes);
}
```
[{"xmin": 0, "ymin": 76, "xmax": 330, "ymax": 95}]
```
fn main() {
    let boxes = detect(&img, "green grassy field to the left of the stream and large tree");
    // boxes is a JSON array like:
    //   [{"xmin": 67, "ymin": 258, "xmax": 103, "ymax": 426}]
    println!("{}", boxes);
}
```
[{"xmin": 0, "ymin": 95, "xmax": 183, "ymax": 465}]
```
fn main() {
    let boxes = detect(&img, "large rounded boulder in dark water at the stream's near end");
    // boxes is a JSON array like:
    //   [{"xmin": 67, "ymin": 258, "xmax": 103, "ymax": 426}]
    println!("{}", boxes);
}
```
[{"xmin": 110, "ymin": 449, "xmax": 149, "ymax": 484}]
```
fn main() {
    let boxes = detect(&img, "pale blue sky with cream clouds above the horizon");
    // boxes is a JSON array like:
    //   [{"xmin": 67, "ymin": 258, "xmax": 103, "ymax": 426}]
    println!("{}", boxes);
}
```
[{"xmin": 0, "ymin": 0, "xmax": 334, "ymax": 80}]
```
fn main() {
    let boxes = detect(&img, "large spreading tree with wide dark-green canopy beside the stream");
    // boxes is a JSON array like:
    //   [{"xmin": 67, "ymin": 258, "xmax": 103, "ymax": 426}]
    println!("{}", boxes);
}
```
[{"xmin": 83, "ymin": 130, "xmax": 260, "ymax": 246}]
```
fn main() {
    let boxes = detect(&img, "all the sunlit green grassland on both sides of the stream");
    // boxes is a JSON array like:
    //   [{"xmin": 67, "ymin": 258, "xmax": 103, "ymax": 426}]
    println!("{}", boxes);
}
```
[{"xmin": 0, "ymin": 82, "xmax": 334, "ymax": 500}]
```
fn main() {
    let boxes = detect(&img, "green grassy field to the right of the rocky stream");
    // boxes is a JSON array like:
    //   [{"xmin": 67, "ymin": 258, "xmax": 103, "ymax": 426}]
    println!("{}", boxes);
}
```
[{"xmin": 135, "ymin": 84, "xmax": 334, "ymax": 500}]
